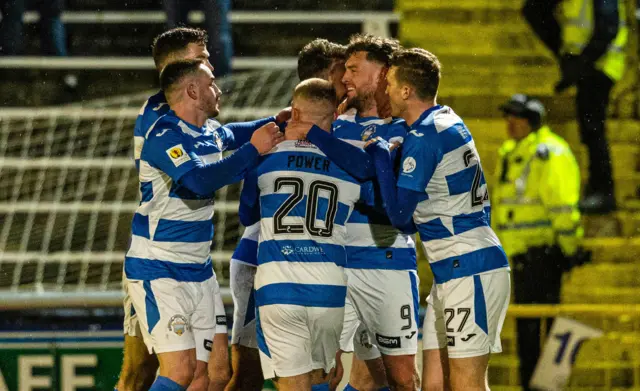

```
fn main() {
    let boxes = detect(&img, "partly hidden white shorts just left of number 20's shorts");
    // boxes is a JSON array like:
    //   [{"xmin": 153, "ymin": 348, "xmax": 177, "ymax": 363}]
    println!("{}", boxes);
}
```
[{"xmin": 229, "ymin": 259, "xmax": 258, "ymax": 349}]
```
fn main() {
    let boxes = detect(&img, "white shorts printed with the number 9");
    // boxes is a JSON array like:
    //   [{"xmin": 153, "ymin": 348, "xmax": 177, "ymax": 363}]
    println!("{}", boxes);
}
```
[{"xmin": 345, "ymin": 269, "xmax": 420, "ymax": 358}]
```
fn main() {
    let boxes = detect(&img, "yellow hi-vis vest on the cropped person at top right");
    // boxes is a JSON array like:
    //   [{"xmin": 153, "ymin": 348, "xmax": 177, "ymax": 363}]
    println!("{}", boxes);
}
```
[{"xmin": 560, "ymin": 0, "xmax": 629, "ymax": 81}]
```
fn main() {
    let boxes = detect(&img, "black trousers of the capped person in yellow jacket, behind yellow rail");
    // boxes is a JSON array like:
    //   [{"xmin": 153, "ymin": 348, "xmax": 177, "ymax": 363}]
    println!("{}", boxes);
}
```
[{"xmin": 511, "ymin": 248, "xmax": 563, "ymax": 391}]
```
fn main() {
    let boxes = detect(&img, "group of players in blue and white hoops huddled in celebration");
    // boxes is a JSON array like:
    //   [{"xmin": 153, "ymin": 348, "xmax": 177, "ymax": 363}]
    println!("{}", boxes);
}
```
[{"xmin": 116, "ymin": 28, "xmax": 510, "ymax": 391}]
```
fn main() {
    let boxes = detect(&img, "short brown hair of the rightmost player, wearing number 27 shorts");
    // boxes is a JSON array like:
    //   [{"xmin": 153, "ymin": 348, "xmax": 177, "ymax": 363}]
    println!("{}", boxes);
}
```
[{"xmin": 391, "ymin": 48, "xmax": 441, "ymax": 100}]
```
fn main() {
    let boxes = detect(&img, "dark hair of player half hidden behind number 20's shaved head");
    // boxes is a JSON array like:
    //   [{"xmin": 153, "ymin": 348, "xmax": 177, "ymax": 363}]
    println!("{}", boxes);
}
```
[{"xmin": 298, "ymin": 38, "xmax": 347, "ymax": 80}]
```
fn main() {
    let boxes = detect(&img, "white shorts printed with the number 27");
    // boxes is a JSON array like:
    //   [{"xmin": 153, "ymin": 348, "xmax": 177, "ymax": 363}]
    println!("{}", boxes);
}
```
[{"xmin": 422, "ymin": 268, "xmax": 511, "ymax": 358}]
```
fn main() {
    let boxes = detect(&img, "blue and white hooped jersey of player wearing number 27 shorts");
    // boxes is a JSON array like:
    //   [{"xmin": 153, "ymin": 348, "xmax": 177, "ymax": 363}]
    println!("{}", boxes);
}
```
[{"xmin": 398, "ymin": 106, "xmax": 508, "ymax": 284}]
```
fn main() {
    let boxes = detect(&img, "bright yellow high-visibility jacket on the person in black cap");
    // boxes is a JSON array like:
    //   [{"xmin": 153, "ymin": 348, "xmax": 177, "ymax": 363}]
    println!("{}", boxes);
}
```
[{"xmin": 491, "ymin": 126, "xmax": 584, "ymax": 257}]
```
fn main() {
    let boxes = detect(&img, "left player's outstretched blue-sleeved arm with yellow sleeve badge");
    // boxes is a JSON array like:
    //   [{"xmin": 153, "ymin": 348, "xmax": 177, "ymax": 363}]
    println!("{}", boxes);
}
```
[{"xmin": 142, "ymin": 130, "xmax": 259, "ymax": 196}]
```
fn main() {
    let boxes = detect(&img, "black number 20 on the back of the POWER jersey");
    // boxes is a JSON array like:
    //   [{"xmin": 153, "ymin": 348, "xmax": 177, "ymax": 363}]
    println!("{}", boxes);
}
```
[{"xmin": 273, "ymin": 177, "xmax": 338, "ymax": 238}]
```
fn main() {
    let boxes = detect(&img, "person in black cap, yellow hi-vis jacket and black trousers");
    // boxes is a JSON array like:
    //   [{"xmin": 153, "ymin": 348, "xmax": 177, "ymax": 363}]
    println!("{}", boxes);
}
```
[{"xmin": 491, "ymin": 95, "xmax": 587, "ymax": 390}]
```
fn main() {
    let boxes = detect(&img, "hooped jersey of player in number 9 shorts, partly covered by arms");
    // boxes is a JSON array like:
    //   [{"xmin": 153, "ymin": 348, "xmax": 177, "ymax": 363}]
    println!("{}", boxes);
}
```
[{"xmin": 333, "ymin": 110, "xmax": 416, "ymax": 270}]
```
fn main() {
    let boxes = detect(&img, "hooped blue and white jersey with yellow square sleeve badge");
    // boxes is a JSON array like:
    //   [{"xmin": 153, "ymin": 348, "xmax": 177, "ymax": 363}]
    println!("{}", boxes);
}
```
[{"xmin": 125, "ymin": 111, "xmax": 233, "ymax": 281}]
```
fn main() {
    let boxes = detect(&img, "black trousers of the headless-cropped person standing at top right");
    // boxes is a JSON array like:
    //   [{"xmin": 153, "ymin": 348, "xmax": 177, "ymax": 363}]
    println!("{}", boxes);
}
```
[{"xmin": 576, "ymin": 69, "xmax": 614, "ymax": 194}]
